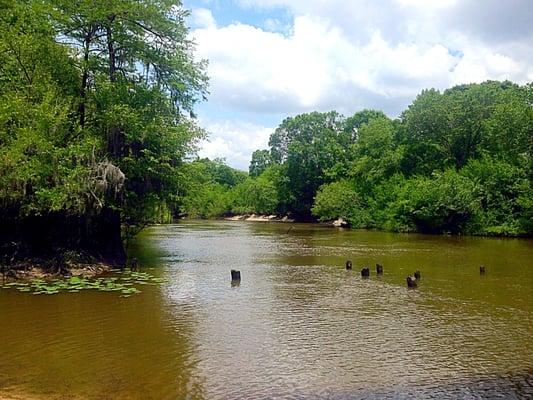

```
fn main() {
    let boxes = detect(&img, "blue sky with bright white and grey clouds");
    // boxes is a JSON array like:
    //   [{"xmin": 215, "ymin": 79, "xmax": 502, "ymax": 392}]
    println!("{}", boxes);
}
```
[{"xmin": 183, "ymin": 0, "xmax": 533, "ymax": 170}]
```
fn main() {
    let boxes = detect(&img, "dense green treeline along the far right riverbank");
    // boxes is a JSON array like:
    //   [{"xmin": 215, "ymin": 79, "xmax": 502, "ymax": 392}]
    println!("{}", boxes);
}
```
[{"xmin": 181, "ymin": 81, "xmax": 533, "ymax": 236}]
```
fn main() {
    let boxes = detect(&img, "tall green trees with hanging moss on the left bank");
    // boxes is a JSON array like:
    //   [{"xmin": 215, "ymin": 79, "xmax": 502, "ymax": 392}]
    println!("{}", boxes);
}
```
[{"xmin": 0, "ymin": 0, "xmax": 207, "ymax": 264}]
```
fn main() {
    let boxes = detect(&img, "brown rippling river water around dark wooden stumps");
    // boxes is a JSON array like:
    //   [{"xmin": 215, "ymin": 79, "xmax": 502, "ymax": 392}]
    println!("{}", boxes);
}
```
[{"xmin": 0, "ymin": 221, "xmax": 533, "ymax": 400}]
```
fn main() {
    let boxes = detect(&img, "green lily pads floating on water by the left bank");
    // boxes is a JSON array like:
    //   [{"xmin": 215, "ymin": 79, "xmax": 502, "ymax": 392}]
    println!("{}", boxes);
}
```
[{"xmin": 0, "ymin": 269, "xmax": 165, "ymax": 297}]
